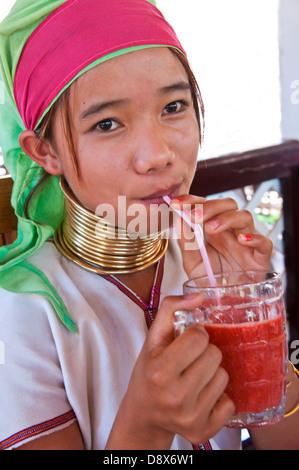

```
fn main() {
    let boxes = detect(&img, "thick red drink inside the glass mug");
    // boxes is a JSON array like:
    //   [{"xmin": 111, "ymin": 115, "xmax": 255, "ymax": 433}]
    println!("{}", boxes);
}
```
[{"xmin": 202, "ymin": 296, "xmax": 286, "ymax": 427}]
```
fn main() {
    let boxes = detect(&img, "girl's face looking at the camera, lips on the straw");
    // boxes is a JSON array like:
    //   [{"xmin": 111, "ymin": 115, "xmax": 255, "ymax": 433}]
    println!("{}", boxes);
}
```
[{"xmin": 53, "ymin": 48, "xmax": 199, "ymax": 229}]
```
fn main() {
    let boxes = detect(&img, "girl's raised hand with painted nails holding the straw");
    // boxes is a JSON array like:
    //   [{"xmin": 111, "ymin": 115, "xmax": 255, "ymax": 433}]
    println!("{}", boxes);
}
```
[{"xmin": 172, "ymin": 195, "xmax": 273, "ymax": 278}]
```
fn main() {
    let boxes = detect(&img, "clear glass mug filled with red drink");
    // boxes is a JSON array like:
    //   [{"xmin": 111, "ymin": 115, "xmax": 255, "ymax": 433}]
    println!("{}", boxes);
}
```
[{"xmin": 174, "ymin": 271, "xmax": 287, "ymax": 428}]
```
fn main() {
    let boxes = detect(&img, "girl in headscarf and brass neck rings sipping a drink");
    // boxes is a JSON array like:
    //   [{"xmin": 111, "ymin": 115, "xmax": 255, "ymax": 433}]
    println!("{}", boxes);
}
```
[{"xmin": 0, "ymin": 0, "xmax": 299, "ymax": 449}]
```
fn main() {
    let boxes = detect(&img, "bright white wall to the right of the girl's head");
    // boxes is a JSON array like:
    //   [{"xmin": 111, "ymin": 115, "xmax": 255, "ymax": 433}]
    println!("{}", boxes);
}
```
[{"xmin": 157, "ymin": 0, "xmax": 284, "ymax": 158}]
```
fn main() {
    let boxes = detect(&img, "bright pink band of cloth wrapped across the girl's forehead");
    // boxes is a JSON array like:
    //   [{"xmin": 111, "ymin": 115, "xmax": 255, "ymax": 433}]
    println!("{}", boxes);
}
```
[{"xmin": 14, "ymin": 0, "xmax": 184, "ymax": 130}]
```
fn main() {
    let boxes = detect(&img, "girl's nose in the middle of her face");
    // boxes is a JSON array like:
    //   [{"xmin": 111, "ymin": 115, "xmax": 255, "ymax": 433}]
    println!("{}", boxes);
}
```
[{"xmin": 134, "ymin": 124, "xmax": 175, "ymax": 174}]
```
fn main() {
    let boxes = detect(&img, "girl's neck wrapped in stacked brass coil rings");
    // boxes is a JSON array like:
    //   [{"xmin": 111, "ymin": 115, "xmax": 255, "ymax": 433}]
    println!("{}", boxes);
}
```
[{"xmin": 54, "ymin": 179, "xmax": 168, "ymax": 280}]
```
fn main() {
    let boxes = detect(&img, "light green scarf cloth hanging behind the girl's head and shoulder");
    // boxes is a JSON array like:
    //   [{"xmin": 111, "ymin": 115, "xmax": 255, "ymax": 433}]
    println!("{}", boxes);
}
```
[{"xmin": 0, "ymin": 0, "xmax": 164, "ymax": 333}]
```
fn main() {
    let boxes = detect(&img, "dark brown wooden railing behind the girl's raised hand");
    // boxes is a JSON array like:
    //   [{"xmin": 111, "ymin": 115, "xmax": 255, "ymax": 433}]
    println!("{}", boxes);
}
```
[{"xmin": 191, "ymin": 141, "xmax": 299, "ymax": 341}]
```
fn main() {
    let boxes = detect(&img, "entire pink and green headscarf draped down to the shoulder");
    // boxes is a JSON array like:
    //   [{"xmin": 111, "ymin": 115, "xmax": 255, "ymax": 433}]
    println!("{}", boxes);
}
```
[{"xmin": 0, "ymin": 0, "xmax": 184, "ymax": 332}]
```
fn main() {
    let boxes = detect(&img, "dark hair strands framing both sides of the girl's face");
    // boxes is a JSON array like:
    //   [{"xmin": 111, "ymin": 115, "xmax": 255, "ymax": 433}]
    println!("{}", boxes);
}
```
[{"xmin": 35, "ymin": 48, "xmax": 205, "ymax": 176}]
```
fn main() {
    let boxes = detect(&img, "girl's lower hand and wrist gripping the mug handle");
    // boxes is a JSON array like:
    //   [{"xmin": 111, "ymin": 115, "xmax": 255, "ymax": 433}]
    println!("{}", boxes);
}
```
[{"xmin": 106, "ymin": 296, "xmax": 234, "ymax": 449}]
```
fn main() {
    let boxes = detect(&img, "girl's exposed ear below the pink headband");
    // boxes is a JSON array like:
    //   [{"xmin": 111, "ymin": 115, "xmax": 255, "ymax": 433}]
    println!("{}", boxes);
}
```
[{"xmin": 19, "ymin": 130, "xmax": 62, "ymax": 175}]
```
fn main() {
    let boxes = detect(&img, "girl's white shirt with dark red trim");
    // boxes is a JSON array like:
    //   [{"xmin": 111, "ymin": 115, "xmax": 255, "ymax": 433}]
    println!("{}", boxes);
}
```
[{"xmin": 0, "ymin": 242, "xmax": 241, "ymax": 450}]
